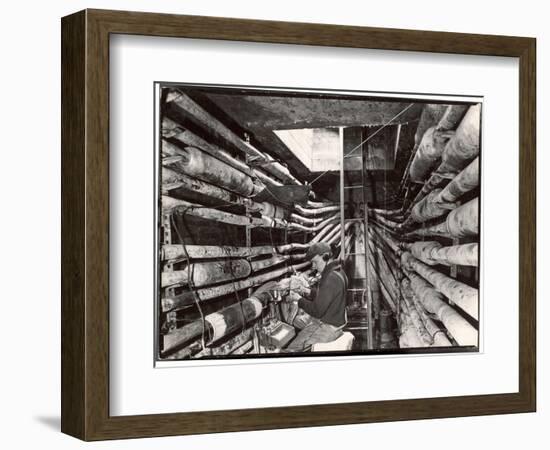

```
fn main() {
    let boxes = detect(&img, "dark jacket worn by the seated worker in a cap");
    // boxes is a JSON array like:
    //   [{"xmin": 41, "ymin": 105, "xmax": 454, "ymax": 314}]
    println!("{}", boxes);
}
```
[{"xmin": 298, "ymin": 261, "xmax": 347, "ymax": 327}]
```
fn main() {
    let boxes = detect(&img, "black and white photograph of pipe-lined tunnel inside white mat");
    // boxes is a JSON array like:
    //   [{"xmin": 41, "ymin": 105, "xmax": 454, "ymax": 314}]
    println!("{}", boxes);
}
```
[{"xmin": 154, "ymin": 82, "xmax": 482, "ymax": 361}]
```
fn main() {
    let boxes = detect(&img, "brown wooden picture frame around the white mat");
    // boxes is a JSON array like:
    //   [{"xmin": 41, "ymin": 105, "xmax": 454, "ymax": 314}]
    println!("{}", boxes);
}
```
[{"xmin": 61, "ymin": 10, "xmax": 536, "ymax": 440}]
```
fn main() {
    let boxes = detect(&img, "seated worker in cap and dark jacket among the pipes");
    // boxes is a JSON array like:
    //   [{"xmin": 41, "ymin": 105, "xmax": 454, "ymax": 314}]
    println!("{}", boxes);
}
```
[{"xmin": 284, "ymin": 242, "xmax": 347, "ymax": 352}]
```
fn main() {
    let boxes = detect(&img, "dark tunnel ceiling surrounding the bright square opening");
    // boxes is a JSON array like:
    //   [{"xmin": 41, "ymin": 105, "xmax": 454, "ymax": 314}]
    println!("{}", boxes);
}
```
[{"xmin": 191, "ymin": 89, "xmax": 434, "ymax": 182}]
